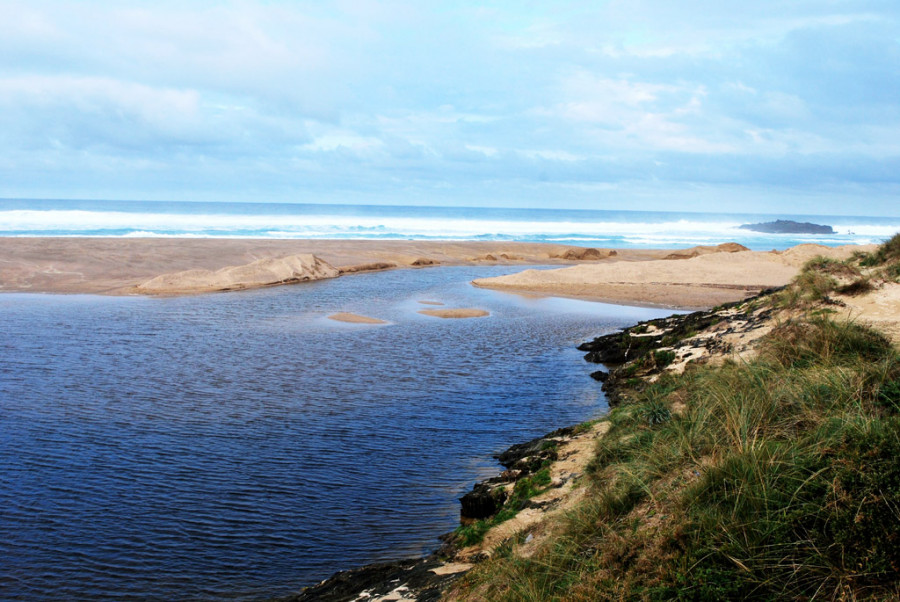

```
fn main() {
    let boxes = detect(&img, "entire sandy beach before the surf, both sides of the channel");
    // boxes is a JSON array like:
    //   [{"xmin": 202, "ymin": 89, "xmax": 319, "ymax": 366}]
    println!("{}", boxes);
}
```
[{"xmin": 0, "ymin": 238, "xmax": 861, "ymax": 308}]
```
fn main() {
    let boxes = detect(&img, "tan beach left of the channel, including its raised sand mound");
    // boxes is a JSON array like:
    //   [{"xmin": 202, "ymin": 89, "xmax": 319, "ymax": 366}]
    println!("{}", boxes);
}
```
[{"xmin": 0, "ymin": 238, "xmax": 658, "ymax": 295}]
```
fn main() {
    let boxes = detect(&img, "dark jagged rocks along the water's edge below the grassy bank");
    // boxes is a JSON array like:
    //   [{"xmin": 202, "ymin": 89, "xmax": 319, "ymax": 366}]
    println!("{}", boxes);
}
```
[{"xmin": 278, "ymin": 289, "xmax": 776, "ymax": 602}]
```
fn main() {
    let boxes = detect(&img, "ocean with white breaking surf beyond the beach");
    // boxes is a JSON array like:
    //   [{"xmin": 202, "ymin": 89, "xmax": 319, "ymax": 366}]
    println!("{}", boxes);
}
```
[{"xmin": 0, "ymin": 199, "xmax": 900, "ymax": 250}]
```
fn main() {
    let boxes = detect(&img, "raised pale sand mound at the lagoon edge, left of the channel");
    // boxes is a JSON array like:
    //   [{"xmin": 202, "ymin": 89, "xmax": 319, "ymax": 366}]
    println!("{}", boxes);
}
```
[{"xmin": 135, "ymin": 254, "xmax": 340, "ymax": 295}]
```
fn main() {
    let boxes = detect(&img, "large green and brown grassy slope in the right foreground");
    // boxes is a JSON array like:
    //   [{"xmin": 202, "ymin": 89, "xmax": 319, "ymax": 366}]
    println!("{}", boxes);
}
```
[{"xmin": 457, "ymin": 317, "xmax": 900, "ymax": 601}]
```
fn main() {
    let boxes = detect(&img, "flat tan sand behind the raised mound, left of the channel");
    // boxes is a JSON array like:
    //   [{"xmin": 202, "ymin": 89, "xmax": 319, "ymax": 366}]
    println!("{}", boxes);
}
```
[{"xmin": 0, "ymin": 237, "xmax": 640, "ymax": 295}]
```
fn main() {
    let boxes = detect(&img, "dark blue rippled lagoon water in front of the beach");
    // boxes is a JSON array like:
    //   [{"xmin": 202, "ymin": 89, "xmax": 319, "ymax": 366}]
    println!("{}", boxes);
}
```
[{"xmin": 0, "ymin": 267, "xmax": 668, "ymax": 600}]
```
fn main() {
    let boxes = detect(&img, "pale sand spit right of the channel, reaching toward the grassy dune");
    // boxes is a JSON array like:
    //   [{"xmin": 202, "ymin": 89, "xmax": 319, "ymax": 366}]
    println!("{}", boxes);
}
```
[{"xmin": 473, "ymin": 245, "xmax": 870, "ymax": 308}]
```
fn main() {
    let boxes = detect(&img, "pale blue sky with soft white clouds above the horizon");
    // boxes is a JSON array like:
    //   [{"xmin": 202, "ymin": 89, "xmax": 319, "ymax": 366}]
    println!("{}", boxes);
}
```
[{"xmin": 0, "ymin": 0, "xmax": 900, "ymax": 216}]
